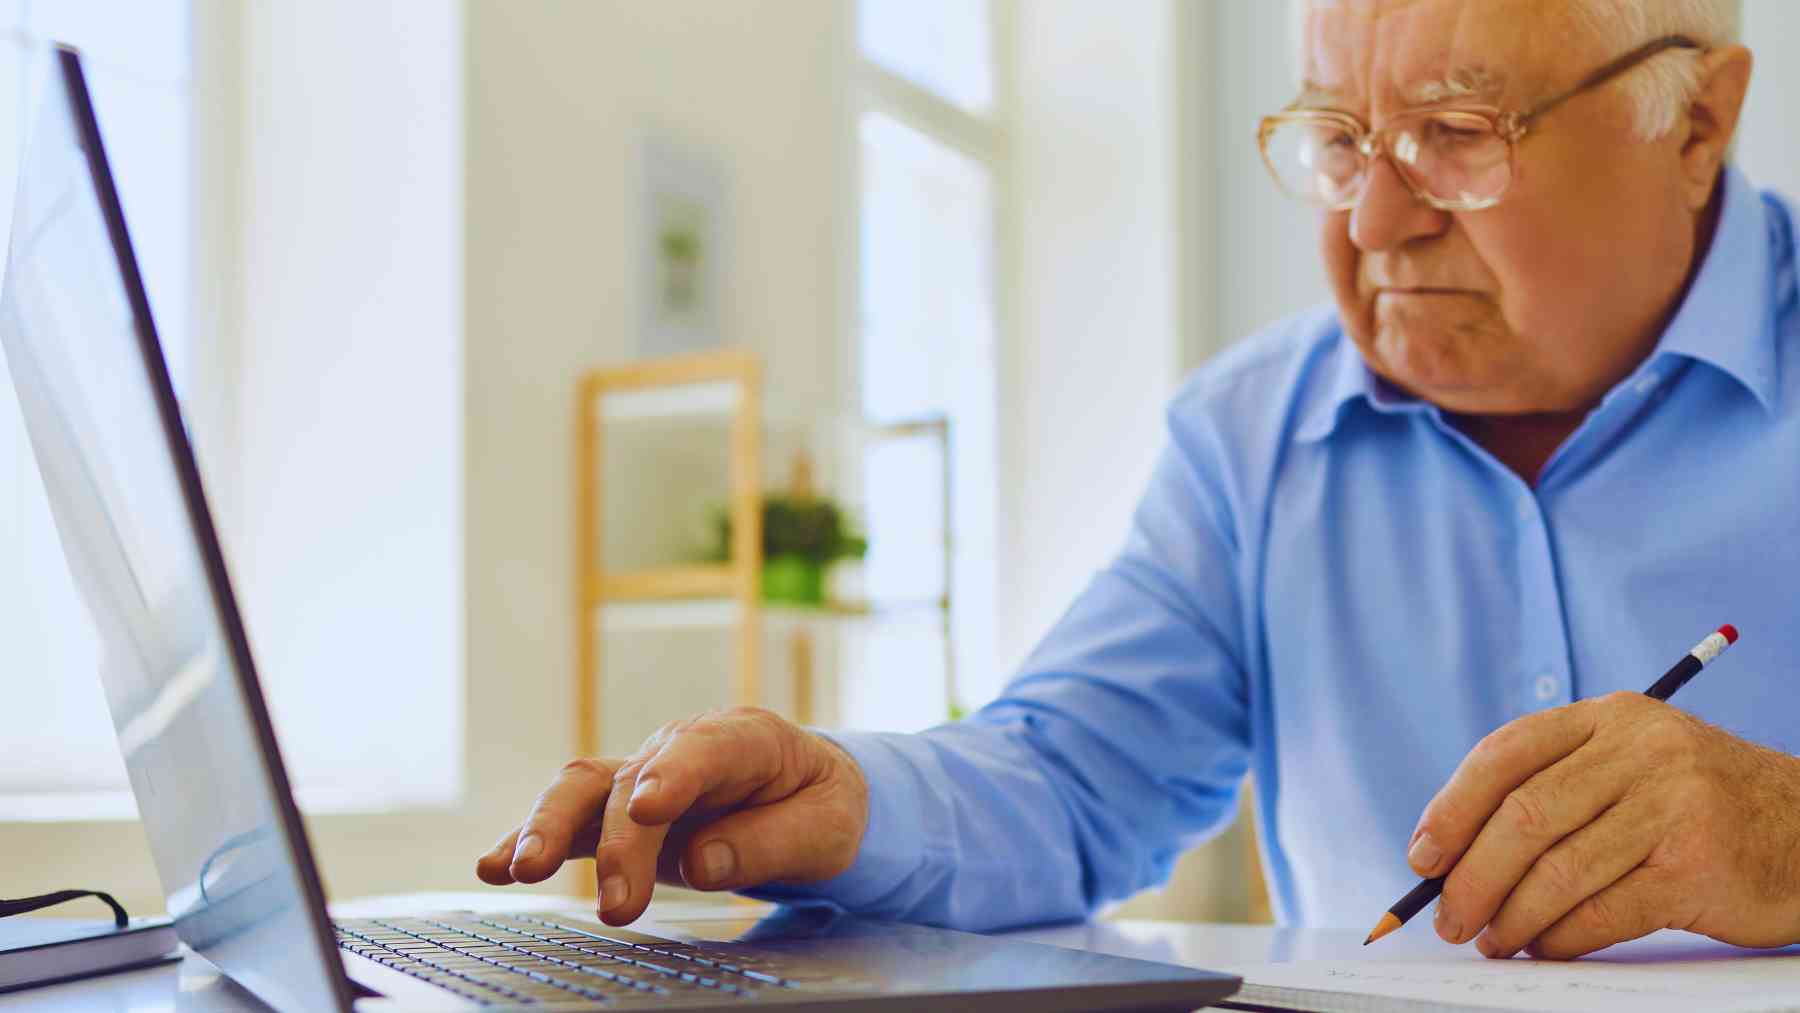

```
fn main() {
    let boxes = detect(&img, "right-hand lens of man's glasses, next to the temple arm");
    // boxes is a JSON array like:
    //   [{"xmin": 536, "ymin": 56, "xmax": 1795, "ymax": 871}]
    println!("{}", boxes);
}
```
[{"xmin": 1388, "ymin": 112, "xmax": 1512, "ymax": 211}]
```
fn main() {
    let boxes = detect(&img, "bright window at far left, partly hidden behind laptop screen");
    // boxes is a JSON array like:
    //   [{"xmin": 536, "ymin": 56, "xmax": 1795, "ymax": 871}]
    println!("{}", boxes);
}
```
[{"xmin": 0, "ymin": 0, "xmax": 191, "ymax": 820}]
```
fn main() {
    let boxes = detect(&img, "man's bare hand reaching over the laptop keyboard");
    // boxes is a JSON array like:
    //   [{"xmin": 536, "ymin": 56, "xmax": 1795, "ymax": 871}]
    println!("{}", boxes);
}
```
[{"xmin": 475, "ymin": 707, "xmax": 869, "ymax": 925}]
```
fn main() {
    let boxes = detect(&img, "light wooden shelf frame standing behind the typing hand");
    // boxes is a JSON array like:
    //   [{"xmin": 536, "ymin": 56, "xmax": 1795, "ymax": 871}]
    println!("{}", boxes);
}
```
[{"xmin": 576, "ymin": 349, "xmax": 763, "ymax": 756}]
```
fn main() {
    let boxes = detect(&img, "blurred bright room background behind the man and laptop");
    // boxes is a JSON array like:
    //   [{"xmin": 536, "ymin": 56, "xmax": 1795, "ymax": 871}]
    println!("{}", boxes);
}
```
[{"xmin": 0, "ymin": 0, "xmax": 1800, "ymax": 919}]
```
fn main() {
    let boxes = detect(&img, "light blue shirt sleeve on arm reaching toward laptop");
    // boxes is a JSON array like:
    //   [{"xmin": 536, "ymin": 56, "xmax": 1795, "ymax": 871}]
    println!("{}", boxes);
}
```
[{"xmin": 752, "ymin": 408, "xmax": 1249, "ymax": 930}]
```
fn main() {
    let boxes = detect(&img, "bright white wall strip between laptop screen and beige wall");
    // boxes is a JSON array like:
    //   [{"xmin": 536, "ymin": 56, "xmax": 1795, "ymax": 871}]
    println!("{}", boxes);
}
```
[{"xmin": 234, "ymin": 0, "xmax": 463, "ymax": 804}]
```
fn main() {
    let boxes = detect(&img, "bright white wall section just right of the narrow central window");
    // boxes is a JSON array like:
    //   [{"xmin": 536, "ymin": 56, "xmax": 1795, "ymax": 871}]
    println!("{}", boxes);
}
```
[{"xmin": 997, "ymin": 0, "xmax": 1183, "ymax": 673}]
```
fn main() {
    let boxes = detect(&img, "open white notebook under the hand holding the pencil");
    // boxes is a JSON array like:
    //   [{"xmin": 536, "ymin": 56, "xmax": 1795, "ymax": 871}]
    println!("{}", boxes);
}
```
[{"xmin": 1226, "ymin": 932, "xmax": 1800, "ymax": 1013}]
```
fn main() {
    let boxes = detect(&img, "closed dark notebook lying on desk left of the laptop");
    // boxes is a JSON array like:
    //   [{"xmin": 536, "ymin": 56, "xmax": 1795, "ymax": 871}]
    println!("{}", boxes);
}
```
[{"xmin": 0, "ymin": 916, "xmax": 180, "ymax": 991}]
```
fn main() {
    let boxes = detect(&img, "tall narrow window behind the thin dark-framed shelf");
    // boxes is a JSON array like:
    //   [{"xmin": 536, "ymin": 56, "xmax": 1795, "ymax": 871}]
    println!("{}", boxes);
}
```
[{"xmin": 842, "ymin": 0, "xmax": 1001, "ymax": 731}]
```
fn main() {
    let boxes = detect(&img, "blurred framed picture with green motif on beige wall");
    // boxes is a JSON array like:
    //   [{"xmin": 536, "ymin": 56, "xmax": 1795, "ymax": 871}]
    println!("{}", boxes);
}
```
[{"xmin": 637, "ymin": 131, "xmax": 729, "ymax": 358}]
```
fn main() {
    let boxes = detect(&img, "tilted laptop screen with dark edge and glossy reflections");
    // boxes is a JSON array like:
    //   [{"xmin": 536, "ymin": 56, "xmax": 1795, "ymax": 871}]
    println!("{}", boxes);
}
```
[{"xmin": 0, "ymin": 50, "xmax": 347, "ymax": 1009}]
